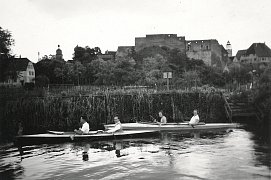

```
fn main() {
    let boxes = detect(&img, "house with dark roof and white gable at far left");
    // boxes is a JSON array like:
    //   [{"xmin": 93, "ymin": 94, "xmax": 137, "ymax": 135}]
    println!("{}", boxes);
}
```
[{"xmin": 5, "ymin": 58, "xmax": 35, "ymax": 86}]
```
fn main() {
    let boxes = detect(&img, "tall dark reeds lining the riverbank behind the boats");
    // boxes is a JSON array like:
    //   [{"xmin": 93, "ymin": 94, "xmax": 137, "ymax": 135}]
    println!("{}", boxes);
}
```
[{"xmin": 0, "ymin": 91, "xmax": 227, "ymax": 141}]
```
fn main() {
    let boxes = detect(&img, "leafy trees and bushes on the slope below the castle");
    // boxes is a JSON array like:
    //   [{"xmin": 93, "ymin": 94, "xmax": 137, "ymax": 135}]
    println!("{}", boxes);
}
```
[{"xmin": 35, "ymin": 46, "xmax": 263, "ymax": 87}]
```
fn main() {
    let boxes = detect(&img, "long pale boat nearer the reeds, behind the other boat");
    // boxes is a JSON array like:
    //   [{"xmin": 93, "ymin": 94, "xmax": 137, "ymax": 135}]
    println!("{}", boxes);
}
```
[{"xmin": 104, "ymin": 123, "xmax": 238, "ymax": 131}]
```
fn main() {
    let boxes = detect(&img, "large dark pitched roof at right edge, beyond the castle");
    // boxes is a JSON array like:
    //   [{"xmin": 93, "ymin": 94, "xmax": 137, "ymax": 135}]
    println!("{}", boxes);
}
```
[{"xmin": 246, "ymin": 43, "xmax": 271, "ymax": 57}]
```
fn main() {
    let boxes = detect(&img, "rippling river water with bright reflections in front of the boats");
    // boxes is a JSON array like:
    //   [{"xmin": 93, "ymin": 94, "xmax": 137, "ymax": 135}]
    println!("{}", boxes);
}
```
[{"xmin": 0, "ymin": 126, "xmax": 271, "ymax": 180}]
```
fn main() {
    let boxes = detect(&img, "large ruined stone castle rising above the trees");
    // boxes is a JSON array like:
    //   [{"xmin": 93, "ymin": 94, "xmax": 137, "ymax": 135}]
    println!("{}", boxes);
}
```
[{"xmin": 116, "ymin": 34, "xmax": 231, "ymax": 67}]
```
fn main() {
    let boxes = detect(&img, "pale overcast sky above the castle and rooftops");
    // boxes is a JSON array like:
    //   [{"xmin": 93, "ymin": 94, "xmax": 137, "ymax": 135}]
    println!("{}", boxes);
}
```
[{"xmin": 0, "ymin": 0, "xmax": 271, "ymax": 62}]
